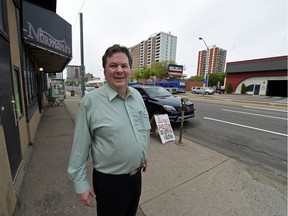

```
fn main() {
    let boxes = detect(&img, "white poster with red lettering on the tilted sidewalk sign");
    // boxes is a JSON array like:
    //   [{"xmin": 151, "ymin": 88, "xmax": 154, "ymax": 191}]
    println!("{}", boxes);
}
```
[{"xmin": 154, "ymin": 114, "xmax": 175, "ymax": 144}]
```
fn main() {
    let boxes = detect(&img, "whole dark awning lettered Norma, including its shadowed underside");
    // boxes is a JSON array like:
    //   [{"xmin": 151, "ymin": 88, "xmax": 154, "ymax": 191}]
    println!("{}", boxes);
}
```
[{"xmin": 22, "ymin": 1, "xmax": 72, "ymax": 73}]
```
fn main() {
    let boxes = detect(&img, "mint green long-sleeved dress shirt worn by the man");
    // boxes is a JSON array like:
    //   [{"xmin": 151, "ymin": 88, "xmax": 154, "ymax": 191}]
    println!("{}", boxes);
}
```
[{"xmin": 67, "ymin": 83, "xmax": 150, "ymax": 193}]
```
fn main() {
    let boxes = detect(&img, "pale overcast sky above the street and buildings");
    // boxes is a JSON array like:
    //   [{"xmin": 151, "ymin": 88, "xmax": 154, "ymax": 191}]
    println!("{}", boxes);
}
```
[{"xmin": 56, "ymin": 0, "xmax": 288, "ymax": 78}]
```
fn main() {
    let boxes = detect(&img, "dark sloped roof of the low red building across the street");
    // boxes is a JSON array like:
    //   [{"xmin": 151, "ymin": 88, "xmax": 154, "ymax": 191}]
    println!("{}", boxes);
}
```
[{"xmin": 226, "ymin": 56, "xmax": 288, "ymax": 73}]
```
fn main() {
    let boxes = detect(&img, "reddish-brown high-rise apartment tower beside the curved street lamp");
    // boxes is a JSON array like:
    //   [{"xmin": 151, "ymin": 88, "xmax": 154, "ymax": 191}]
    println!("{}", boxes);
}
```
[{"xmin": 197, "ymin": 46, "xmax": 227, "ymax": 76}]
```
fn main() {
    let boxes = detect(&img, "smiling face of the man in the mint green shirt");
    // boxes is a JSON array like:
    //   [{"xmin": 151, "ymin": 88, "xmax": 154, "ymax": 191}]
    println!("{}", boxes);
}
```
[{"xmin": 104, "ymin": 52, "xmax": 131, "ymax": 92}]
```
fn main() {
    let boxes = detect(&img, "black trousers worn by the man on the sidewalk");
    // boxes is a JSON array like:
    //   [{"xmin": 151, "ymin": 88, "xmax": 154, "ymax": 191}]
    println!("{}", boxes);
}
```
[{"xmin": 93, "ymin": 169, "xmax": 142, "ymax": 216}]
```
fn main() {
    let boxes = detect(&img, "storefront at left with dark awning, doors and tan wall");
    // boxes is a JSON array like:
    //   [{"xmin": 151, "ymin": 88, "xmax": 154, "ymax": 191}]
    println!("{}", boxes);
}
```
[{"xmin": 0, "ymin": 0, "xmax": 72, "ymax": 215}]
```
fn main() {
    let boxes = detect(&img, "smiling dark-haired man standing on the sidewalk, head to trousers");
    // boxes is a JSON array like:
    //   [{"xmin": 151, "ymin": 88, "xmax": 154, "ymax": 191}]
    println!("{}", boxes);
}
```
[{"xmin": 68, "ymin": 45, "xmax": 150, "ymax": 216}]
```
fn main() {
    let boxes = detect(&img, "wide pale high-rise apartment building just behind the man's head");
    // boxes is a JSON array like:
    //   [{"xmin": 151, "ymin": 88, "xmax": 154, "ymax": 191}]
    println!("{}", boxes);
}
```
[{"xmin": 129, "ymin": 32, "xmax": 177, "ymax": 71}]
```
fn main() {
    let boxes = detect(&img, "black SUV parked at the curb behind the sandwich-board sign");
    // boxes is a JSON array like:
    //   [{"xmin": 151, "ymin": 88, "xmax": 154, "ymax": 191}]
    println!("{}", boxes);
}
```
[{"xmin": 132, "ymin": 85, "xmax": 195, "ymax": 123}]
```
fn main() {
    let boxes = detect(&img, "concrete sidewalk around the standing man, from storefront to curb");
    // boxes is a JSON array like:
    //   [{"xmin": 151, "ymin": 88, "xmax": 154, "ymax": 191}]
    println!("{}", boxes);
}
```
[{"xmin": 15, "ymin": 92, "xmax": 287, "ymax": 216}]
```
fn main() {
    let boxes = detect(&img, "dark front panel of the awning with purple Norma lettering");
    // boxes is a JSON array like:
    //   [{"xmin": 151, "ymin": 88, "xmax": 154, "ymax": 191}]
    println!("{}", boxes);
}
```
[{"xmin": 23, "ymin": 1, "xmax": 72, "ymax": 57}]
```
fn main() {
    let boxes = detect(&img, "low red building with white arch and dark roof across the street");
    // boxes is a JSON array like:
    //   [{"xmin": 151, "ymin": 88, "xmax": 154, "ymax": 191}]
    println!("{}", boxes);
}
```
[{"xmin": 226, "ymin": 56, "xmax": 288, "ymax": 97}]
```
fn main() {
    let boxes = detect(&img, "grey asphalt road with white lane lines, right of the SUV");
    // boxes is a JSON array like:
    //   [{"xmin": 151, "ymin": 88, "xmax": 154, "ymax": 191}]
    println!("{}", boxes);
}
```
[{"xmin": 173, "ymin": 97, "xmax": 287, "ymax": 182}]
